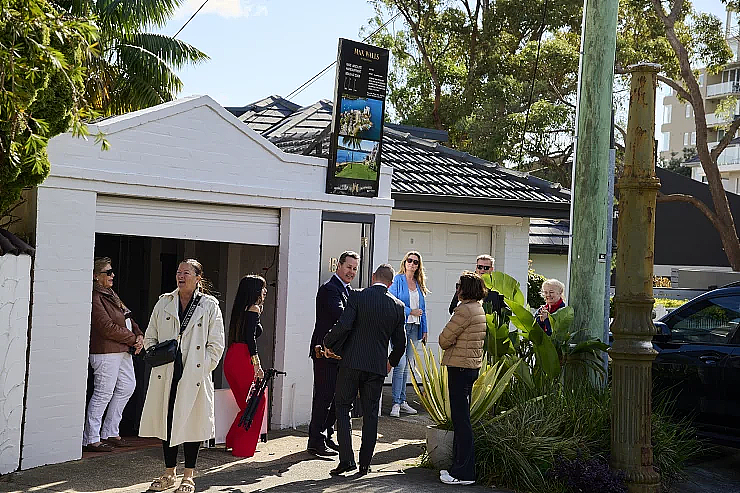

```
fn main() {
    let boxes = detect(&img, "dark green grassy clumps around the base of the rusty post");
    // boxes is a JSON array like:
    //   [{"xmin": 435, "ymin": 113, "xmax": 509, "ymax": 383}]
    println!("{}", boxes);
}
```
[{"xmin": 474, "ymin": 382, "xmax": 701, "ymax": 493}]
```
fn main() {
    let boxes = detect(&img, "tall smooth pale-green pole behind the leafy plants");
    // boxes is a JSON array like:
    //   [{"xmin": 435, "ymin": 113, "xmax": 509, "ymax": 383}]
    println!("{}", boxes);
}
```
[{"xmin": 568, "ymin": 0, "xmax": 619, "ymax": 368}]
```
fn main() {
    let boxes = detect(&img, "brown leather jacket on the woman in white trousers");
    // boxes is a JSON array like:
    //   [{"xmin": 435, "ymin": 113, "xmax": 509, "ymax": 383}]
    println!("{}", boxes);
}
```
[{"xmin": 90, "ymin": 289, "xmax": 144, "ymax": 354}]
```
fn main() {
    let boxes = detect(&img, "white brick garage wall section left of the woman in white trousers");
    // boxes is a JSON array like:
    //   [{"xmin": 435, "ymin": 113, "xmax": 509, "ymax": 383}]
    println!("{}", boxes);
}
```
[{"xmin": 21, "ymin": 187, "xmax": 95, "ymax": 469}]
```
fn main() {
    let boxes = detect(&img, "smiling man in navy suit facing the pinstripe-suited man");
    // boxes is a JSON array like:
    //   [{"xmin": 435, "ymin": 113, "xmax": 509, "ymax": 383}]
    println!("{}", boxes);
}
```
[{"xmin": 306, "ymin": 251, "xmax": 360, "ymax": 457}]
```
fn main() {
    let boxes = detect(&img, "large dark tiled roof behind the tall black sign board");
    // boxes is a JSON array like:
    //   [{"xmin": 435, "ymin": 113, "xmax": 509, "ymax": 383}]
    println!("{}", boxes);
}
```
[{"xmin": 228, "ymin": 99, "xmax": 570, "ymax": 219}]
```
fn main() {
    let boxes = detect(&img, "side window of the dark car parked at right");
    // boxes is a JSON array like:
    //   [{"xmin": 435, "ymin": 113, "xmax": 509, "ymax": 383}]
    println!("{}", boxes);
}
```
[{"xmin": 668, "ymin": 296, "xmax": 740, "ymax": 344}]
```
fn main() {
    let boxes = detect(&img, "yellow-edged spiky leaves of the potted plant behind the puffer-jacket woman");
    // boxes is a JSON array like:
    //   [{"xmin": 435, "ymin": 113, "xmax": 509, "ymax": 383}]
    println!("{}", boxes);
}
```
[{"xmin": 410, "ymin": 344, "xmax": 519, "ymax": 430}]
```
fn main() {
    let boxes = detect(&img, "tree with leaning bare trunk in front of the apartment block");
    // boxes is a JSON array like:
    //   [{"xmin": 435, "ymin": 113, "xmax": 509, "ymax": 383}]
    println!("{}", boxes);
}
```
[{"xmin": 617, "ymin": 0, "xmax": 740, "ymax": 271}]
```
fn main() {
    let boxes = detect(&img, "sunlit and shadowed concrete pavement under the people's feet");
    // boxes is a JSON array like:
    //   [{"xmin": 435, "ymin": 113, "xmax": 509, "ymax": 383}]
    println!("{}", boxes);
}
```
[{"xmin": 0, "ymin": 399, "xmax": 505, "ymax": 493}]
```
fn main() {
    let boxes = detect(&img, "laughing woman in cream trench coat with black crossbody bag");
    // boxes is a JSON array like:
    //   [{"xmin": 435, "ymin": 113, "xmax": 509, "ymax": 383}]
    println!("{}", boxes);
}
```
[{"xmin": 139, "ymin": 259, "xmax": 224, "ymax": 493}]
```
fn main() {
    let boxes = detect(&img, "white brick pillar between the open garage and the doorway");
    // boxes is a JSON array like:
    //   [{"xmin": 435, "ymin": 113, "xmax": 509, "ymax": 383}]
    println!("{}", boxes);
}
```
[{"xmin": 272, "ymin": 208, "xmax": 321, "ymax": 428}]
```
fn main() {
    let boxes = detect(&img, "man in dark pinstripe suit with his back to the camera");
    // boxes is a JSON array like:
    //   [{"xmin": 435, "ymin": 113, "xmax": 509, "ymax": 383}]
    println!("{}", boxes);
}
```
[{"xmin": 324, "ymin": 264, "xmax": 406, "ymax": 476}]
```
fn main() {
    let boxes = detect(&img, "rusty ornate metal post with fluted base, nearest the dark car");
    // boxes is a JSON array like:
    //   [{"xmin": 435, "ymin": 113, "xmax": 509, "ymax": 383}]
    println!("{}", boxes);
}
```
[{"xmin": 609, "ymin": 63, "xmax": 660, "ymax": 493}]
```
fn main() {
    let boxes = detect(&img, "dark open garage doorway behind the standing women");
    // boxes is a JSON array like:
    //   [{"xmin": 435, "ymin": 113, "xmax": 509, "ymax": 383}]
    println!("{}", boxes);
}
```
[{"xmin": 87, "ymin": 233, "xmax": 278, "ymax": 443}]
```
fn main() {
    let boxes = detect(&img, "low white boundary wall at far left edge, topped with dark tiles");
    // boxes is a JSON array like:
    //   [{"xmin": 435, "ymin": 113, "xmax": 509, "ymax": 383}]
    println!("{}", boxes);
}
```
[{"xmin": 0, "ymin": 255, "xmax": 31, "ymax": 474}]
